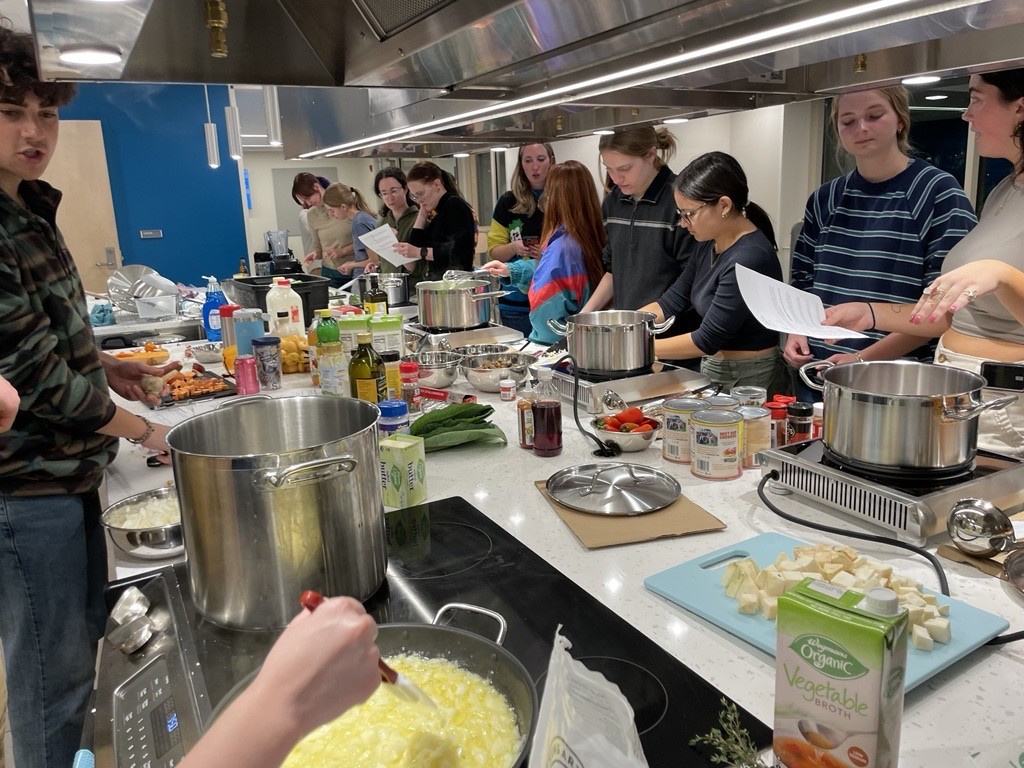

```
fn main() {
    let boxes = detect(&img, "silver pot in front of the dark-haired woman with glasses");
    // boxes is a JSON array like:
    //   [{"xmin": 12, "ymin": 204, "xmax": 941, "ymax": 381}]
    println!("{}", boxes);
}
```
[{"xmin": 548, "ymin": 309, "xmax": 676, "ymax": 374}]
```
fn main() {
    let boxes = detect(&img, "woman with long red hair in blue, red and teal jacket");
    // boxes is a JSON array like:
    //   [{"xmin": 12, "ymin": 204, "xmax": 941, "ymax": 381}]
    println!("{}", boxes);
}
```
[{"xmin": 483, "ymin": 160, "xmax": 606, "ymax": 344}]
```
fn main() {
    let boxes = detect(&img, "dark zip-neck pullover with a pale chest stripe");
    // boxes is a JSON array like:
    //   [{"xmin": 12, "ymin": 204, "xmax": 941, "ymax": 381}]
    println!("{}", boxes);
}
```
[{"xmin": 601, "ymin": 166, "xmax": 696, "ymax": 313}]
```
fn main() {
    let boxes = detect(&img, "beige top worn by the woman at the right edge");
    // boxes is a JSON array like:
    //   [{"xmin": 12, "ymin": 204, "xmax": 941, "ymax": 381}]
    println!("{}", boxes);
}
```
[{"xmin": 942, "ymin": 176, "xmax": 1024, "ymax": 344}]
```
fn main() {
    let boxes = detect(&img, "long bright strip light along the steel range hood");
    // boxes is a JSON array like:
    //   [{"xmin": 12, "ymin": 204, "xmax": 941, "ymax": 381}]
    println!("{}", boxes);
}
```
[{"xmin": 299, "ymin": 0, "xmax": 985, "ymax": 158}]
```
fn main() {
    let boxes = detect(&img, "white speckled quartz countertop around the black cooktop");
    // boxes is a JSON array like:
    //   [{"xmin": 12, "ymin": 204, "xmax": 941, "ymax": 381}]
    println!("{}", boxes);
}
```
[{"xmin": 106, "ymin": 344, "xmax": 1024, "ymax": 768}]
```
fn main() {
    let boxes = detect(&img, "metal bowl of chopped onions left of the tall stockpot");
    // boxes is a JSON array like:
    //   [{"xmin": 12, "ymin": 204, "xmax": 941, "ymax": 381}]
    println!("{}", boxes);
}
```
[{"xmin": 99, "ymin": 486, "xmax": 185, "ymax": 560}]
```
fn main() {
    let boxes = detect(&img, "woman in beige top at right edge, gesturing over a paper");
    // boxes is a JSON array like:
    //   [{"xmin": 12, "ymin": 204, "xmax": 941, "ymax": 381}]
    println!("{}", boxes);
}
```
[{"xmin": 826, "ymin": 69, "xmax": 1024, "ymax": 458}]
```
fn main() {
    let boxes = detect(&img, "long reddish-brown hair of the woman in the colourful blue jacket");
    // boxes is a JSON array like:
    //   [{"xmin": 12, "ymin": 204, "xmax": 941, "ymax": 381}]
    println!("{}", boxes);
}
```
[{"xmin": 541, "ymin": 160, "xmax": 607, "ymax": 291}]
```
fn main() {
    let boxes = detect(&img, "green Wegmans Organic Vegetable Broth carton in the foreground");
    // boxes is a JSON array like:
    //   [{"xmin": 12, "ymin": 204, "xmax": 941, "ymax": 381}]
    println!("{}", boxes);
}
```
[{"xmin": 773, "ymin": 579, "xmax": 907, "ymax": 768}]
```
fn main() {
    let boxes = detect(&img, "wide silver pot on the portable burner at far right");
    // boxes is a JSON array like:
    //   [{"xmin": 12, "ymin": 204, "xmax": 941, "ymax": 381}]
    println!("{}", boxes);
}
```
[{"xmin": 800, "ymin": 360, "xmax": 1017, "ymax": 470}]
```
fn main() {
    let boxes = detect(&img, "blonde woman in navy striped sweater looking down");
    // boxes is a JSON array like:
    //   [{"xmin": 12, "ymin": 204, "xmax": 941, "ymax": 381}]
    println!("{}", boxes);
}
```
[{"xmin": 784, "ymin": 86, "xmax": 977, "ymax": 397}]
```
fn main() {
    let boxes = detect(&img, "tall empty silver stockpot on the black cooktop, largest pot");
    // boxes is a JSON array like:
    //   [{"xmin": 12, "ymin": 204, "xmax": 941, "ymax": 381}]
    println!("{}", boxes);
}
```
[{"xmin": 167, "ymin": 396, "xmax": 387, "ymax": 629}]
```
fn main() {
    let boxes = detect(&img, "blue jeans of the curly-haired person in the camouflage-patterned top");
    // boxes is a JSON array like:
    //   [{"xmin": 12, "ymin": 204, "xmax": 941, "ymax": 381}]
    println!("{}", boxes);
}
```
[{"xmin": 0, "ymin": 493, "xmax": 106, "ymax": 768}]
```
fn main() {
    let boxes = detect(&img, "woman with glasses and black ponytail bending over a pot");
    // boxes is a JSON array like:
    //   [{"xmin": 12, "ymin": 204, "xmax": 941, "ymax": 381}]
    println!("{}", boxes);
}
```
[{"xmin": 641, "ymin": 152, "xmax": 791, "ymax": 394}]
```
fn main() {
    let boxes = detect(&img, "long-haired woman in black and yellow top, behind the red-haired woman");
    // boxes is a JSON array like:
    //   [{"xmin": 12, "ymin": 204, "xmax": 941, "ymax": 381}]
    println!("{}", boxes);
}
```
[{"xmin": 487, "ymin": 143, "xmax": 555, "ymax": 336}]
